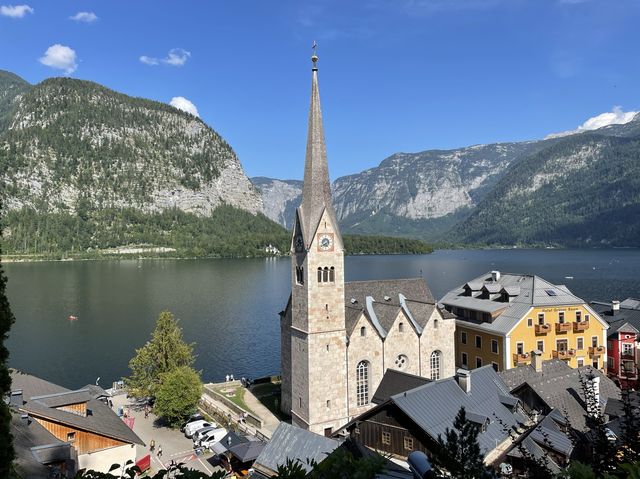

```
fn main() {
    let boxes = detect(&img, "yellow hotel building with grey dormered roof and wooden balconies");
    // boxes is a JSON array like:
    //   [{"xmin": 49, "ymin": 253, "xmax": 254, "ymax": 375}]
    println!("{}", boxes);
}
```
[{"xmin": 440, "ymin": 271, "xmax": 609, "ymax": 371}]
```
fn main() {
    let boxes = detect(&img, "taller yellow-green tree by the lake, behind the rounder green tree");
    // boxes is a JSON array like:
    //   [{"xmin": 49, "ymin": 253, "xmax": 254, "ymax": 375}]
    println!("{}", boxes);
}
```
[{"xmin": 124, "ymin": 311, "xmax": 195, "ymax": 397}]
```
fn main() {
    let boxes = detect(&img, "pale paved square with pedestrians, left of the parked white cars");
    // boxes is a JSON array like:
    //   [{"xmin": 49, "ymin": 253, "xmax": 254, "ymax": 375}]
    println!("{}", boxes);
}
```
[{"xmin": 112, "ymin": 394, "xmax": 221, "ymax": 475}]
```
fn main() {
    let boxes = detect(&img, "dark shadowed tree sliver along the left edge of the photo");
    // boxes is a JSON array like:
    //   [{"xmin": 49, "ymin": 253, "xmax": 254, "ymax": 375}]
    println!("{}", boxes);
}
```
[{"xmin": 0, "ymin": 201, "xmax": 15, "ymax": 477}]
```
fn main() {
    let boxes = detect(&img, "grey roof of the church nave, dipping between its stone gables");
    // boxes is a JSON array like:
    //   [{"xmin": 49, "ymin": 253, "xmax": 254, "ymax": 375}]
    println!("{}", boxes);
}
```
[{"xmin": 344, "ymin": 278, "xmax": 435, "ymax": 338}]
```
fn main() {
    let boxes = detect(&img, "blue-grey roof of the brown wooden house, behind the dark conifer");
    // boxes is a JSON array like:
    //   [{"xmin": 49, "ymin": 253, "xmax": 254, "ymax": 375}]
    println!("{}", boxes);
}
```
[{"xmin": 391, "ymin": 366, "xmax": 527, "ymax": 454}]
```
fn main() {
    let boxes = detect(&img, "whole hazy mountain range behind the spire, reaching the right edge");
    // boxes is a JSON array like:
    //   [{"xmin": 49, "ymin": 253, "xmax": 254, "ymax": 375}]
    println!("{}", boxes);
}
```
[{"xmin": 257, "ymin": 114, "xmax": 640, "ymax": 246}]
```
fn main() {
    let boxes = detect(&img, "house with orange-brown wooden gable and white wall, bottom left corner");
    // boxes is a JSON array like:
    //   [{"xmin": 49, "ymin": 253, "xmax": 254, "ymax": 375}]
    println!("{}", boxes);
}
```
[{"xmin": 9, "ymin": 370, "xmax": 144, "ymax": 477}]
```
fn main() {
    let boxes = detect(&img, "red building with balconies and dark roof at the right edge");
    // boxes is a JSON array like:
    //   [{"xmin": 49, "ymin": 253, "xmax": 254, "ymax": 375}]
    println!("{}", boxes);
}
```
[{"xmin": 591, "ymin": 298, "xmax": 640, "ymax": 388}]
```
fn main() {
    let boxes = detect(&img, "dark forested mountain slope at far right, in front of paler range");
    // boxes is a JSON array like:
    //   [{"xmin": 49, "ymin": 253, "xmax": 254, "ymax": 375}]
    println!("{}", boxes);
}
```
[{"xmin": 452, "ymin": 114, "xmax": 640, "ymax": 246}]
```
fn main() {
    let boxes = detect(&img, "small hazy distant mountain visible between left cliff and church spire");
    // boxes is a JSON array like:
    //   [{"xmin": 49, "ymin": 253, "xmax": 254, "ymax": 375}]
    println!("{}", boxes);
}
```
[{"xmin": 251, "ymin": 176, "xmax": 302, "ymax": 229}]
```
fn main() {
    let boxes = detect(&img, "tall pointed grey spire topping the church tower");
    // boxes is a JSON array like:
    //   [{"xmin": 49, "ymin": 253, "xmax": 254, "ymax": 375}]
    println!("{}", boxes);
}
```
[{"xmin": 299, "ymin": 47, "xmax": 342, "ymax": 248}]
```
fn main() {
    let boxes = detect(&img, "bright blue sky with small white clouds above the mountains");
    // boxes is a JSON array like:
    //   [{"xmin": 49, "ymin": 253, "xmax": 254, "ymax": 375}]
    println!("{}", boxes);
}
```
[{"xmin": 0, "ymin": 0, "xmax": 640, "ymax": 179}]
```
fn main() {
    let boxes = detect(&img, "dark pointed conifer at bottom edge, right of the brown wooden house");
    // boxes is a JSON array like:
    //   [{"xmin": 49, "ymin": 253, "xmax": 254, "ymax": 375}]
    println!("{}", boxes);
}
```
[{"xmin": 433, "ymin": 406, "xmax": 492, "ymax": 479}]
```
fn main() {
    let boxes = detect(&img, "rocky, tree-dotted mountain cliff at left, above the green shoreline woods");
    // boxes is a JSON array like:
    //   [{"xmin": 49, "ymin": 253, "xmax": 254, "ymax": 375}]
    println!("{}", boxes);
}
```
[{"xmin": 0, "ymin": 74, "xmax": 262, "ymax": 215}]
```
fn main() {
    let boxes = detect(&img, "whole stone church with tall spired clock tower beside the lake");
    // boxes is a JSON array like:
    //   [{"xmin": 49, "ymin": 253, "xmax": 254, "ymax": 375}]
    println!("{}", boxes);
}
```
[{"xmin": 280, "ymin": 53, "xmax": 455, "ymax": 436}]
